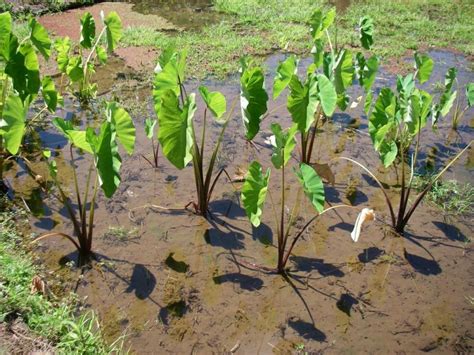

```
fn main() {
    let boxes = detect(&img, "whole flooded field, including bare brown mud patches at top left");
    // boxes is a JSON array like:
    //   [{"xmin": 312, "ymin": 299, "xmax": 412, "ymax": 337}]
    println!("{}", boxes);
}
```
[{"xmin": 1, "ymin": 0, "xmax": 474, "ymax": 354}]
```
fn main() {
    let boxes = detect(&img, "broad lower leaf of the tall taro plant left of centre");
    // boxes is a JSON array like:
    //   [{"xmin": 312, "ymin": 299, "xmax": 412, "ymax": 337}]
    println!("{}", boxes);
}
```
[{"xmin": 158, "ymin": 90, "xmax": 196, "ymax": 169}]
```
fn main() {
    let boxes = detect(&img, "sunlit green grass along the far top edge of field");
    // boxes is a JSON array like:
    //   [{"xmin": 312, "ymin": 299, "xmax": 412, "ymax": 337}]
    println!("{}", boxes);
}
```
[{"xmin": 115, "ymin": 0, "xmax": 474, "ymax": 78}]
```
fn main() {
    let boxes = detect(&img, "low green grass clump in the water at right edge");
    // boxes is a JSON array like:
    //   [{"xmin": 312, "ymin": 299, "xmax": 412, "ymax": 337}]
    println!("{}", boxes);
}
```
[{"xmin": 414, "ymin": 175, "xmax": 474, "ymax": 215}]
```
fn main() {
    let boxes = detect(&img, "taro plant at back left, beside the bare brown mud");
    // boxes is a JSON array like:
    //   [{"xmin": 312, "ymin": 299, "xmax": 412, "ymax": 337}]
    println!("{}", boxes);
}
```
[{"xmin": 54, "ymin": 11, "xmax": 122, "ymax": 104}]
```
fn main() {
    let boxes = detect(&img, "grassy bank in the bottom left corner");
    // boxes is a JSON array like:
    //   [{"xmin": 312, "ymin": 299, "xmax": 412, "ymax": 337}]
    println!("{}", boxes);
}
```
[{"xmin": 0, "ymin": 206, "xmax": 120, "ymax": 354}]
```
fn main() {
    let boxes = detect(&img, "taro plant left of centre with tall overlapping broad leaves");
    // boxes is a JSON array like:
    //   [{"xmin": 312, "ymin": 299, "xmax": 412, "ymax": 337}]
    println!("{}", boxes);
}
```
[{"xmin": 150, "ymin": 48, "xmax": 235, "ymax": 217}]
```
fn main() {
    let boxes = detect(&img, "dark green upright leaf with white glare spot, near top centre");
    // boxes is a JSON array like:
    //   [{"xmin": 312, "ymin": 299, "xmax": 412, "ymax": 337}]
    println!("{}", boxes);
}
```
[{"xmin": 240, "ymin": 67, "xmax": 268, "ymax": 140}]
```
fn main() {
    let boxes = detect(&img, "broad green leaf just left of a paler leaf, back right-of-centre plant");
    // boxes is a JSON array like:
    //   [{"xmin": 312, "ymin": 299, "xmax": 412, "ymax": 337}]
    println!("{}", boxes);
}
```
[{"xmin": 287, "ymin": 75, "xmax": 319, "ymax": 132}]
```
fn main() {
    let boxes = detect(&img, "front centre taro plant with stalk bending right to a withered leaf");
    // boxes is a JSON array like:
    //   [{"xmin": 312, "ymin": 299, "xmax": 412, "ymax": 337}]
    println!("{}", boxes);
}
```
[{"xmin": 241, "ymin": 123, "xmax": 360, "ymax": 274}]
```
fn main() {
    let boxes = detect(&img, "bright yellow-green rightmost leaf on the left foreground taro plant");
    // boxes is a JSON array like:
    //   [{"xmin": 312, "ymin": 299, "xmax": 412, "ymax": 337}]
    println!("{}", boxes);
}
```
[{"xmin": 106, "ymin": 102, "xmax": 135, "ymax": 155}]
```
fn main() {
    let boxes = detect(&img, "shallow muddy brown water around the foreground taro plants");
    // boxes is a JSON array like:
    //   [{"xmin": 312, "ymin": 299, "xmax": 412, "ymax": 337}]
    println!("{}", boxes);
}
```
[{"xmin": 8, "ymin": 52, "xmax": 474, "ymax": 354}]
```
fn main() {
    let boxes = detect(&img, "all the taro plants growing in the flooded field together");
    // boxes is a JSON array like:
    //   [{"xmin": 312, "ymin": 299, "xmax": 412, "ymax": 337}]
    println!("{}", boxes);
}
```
[{"xmin": 0, "ymin": 5, "xmax": 474, "ymax": 280}]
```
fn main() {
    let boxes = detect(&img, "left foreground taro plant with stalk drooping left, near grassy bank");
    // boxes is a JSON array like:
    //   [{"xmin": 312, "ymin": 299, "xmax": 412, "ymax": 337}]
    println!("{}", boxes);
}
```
[{"xmin": 36, "ymin": 102, "xmax": 135, "ymax": 260}]
